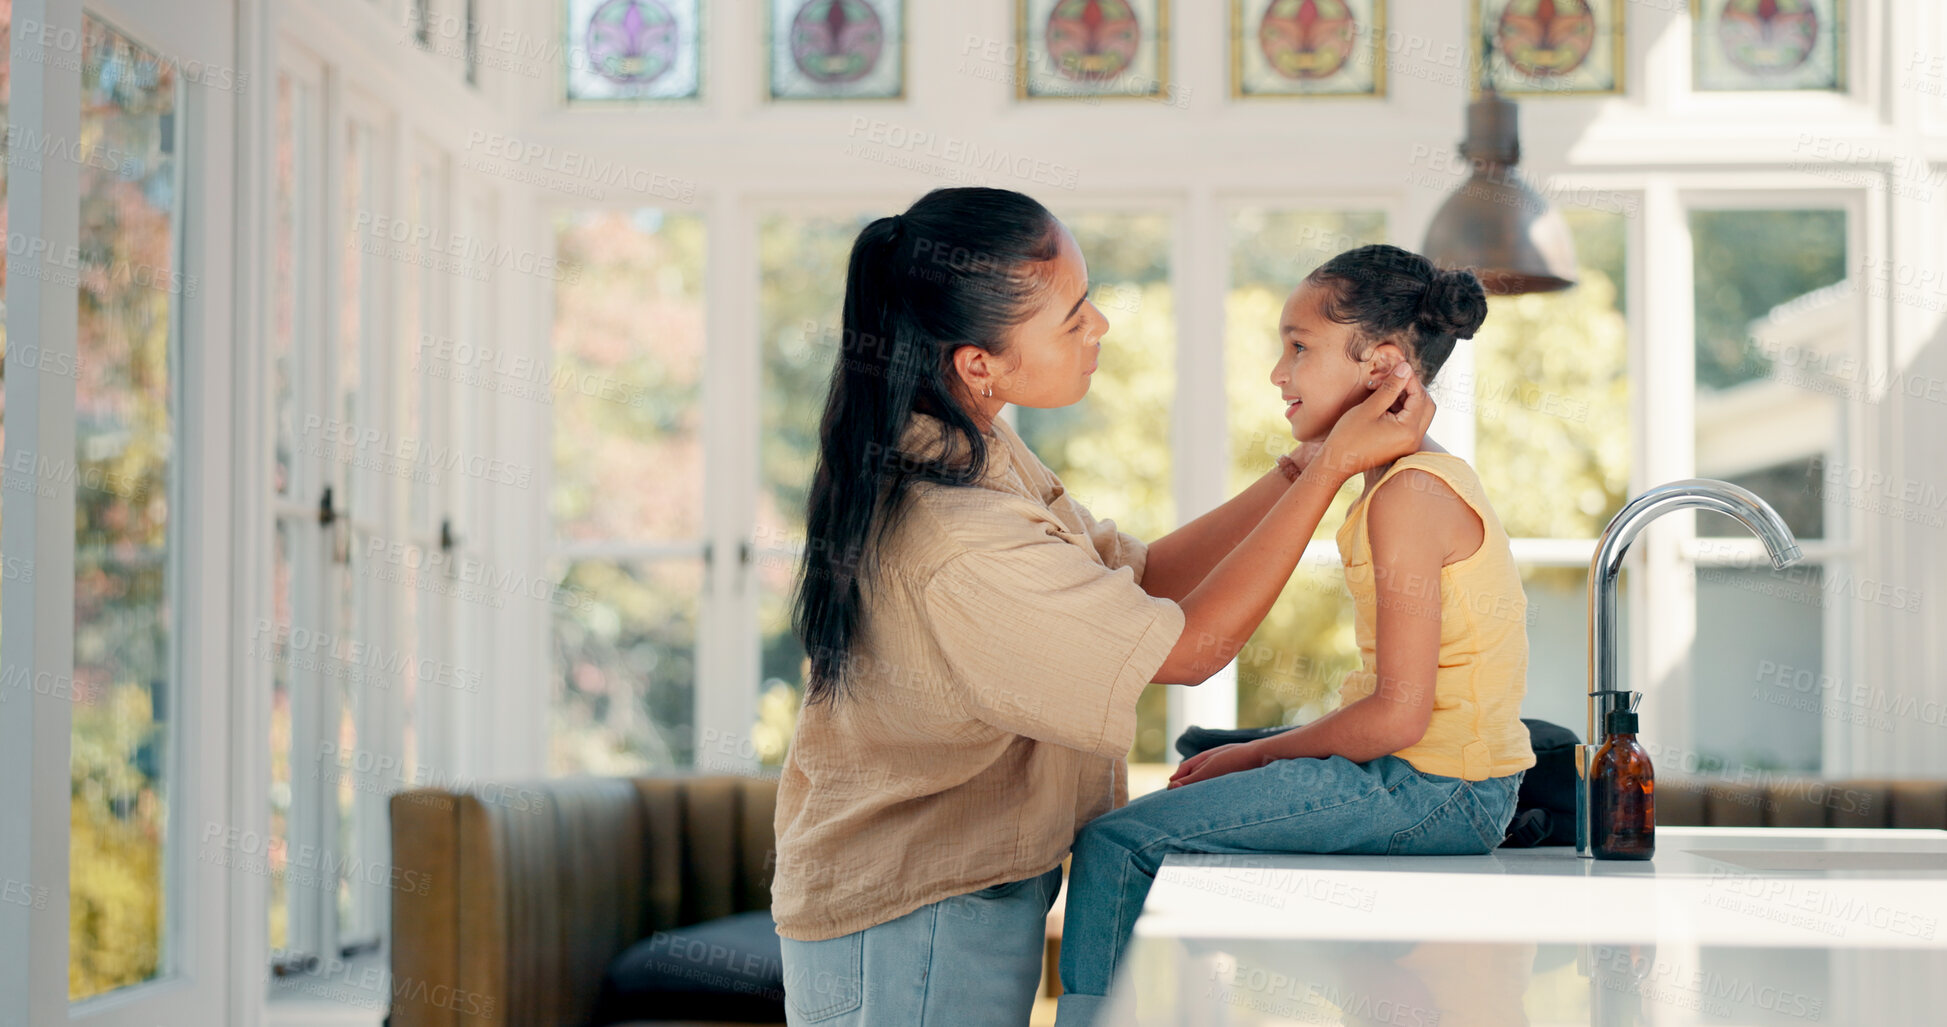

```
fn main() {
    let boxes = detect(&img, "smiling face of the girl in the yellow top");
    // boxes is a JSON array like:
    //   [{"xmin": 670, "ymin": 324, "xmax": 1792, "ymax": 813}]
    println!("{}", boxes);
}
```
[{"xmin": 1271, "ymin": 283, "xmax": 1402, "ymax": 442}]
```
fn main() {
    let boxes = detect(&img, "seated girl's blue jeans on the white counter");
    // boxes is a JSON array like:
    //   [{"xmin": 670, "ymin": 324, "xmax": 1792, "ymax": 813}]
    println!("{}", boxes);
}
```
[{"xmin": 1057, "ymin": 756, "xmax": 1521, "ymax": 1027}]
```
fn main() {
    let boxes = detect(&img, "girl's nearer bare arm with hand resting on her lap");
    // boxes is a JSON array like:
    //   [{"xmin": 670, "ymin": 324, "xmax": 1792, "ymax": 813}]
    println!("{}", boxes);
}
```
[{"xmin": 1170, "ymin": 470, "xmax": 1480, "ymax": 787}]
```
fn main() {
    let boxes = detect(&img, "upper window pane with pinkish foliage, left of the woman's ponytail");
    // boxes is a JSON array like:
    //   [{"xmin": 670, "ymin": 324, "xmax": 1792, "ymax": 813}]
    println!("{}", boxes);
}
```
[{"xmin": 553, "ymin": 209, "xmax": 703, "ymax": 542}]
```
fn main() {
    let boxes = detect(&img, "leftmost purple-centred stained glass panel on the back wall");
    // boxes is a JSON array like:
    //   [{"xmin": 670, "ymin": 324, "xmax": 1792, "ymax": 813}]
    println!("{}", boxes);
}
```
[{"xmin": 565, "ymin": 0, "xmax": 703, "ymax": 101}]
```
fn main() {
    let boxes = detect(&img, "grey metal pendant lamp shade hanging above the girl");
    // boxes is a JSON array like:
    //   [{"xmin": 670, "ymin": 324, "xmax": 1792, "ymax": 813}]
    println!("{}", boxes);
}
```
[{"xmin": 1421, "ymin": 90, "xmax": 1575, "ymax": 296}]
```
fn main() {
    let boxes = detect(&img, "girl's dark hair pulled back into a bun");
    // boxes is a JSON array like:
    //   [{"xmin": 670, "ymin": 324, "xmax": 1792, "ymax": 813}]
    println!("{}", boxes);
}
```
[{"xmin": 1304, "ymin": 244, "xmax": 1488, "ymax": 384}]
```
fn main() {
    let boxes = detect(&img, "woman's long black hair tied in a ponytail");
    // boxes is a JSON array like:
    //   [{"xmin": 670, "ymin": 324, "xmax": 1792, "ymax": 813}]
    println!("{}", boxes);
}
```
[{"xmin": 792, "ymin": 189, "xmax": 1059, "ymax": 702}]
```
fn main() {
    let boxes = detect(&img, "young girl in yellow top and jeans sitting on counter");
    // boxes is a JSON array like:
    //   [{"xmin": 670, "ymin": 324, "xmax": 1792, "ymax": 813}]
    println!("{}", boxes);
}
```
[{"xmin": 1059, "ymin": 246, "xmax": 1534, "ymax": 1027}]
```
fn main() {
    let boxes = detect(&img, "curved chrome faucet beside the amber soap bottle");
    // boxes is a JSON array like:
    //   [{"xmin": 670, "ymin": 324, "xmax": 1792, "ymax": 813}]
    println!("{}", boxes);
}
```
[{"xmin": 1575, "ymin": 477, "xmax": 1803, "ymax": 856}]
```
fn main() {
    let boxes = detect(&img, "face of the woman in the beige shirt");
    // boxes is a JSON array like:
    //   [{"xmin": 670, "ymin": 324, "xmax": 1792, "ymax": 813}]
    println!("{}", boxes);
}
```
[{"xmin": 960, "ymin": 224, "xmax": 1108, "ymax": 417}]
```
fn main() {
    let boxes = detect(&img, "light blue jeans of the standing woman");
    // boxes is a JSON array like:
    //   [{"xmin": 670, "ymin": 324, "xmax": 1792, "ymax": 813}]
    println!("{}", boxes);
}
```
[{"xmin": 779, "ymin": 865, "xmax": 1061, "ymax": 1027}]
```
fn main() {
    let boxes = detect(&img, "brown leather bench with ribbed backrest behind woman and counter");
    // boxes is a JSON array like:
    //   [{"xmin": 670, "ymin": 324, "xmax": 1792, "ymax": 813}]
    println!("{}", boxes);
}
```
[{"xmin": 391, "ymin": 778, "xmax": 1947, "ymax": 1027}]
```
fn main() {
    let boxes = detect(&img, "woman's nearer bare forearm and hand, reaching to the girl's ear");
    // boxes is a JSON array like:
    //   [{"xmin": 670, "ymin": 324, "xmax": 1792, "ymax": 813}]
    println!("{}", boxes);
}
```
[{"xmin": 1145, "ymin": 361, "xmax": 1433, "ymax": 684}]
